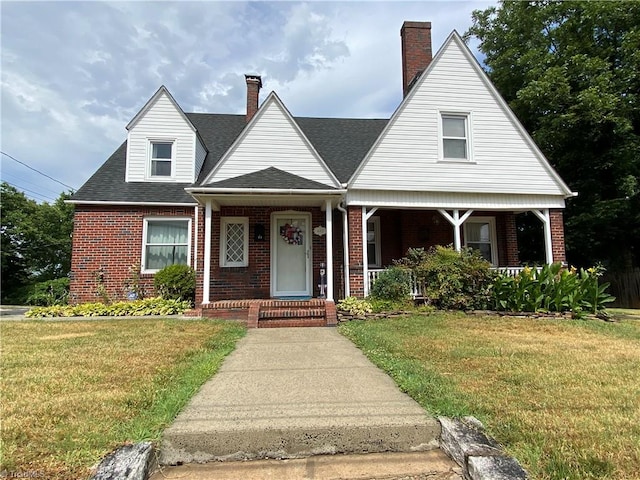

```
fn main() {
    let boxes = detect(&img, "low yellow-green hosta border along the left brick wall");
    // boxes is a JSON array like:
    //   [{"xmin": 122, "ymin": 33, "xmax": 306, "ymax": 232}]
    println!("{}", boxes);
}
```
[{"xmin": 25, "ymin": 297, "xmax": 191, "ymax": 318}]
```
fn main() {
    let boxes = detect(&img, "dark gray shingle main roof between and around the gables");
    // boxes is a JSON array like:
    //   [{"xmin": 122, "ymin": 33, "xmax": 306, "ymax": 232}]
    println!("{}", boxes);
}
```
[{"xmin": 72, "ymin": 113, "xmax": 388, "ymax": 203}]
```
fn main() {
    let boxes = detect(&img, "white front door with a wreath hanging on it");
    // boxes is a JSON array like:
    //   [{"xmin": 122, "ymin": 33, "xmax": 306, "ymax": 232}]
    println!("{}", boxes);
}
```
[{"xmin": 271, "ymin": 212, "xmax": 312, "ymax": 297}]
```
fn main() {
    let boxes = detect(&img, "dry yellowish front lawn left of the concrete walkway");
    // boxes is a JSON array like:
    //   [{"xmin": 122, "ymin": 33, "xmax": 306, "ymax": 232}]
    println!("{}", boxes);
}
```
[{"xmin": 0, "ymin": 319, "xmax": 245, "ymax": 479}]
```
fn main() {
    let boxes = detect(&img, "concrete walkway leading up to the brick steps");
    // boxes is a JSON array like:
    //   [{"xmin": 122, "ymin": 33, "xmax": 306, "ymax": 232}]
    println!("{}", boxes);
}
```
[{"xmin": 159, "ymin": 327, "xmax": 440, "ymax": 464}]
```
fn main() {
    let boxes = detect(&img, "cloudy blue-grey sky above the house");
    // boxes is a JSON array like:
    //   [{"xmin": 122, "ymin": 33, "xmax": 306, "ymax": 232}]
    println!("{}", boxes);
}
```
[{"xmin": 0, "ymin": 0, "xmax": 495, "ymax": 202}]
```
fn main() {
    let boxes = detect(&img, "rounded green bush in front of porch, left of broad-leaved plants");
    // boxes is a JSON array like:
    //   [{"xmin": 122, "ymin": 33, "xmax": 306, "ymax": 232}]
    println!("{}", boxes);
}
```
[{"xmin": 396, "ymin": 245, "xmax": 494, "ymax": 310}]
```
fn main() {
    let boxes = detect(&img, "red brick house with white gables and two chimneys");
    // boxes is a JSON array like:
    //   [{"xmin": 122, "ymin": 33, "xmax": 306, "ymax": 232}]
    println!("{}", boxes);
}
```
[{"xmin": 71, "ymin": 22, "xmax": 572, "ymax": 324}]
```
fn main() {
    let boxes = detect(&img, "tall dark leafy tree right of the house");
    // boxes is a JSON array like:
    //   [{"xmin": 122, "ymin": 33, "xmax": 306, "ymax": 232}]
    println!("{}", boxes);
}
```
[{"xmin": 466, "ymin": 1, "xmax": 640, "ymax": 268}]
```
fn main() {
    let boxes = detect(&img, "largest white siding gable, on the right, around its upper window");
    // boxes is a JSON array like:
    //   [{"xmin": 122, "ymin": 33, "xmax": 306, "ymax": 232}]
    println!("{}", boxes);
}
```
[{"xmin": 349, "ymin": 32, "xmax": 571, "ymax": 196}]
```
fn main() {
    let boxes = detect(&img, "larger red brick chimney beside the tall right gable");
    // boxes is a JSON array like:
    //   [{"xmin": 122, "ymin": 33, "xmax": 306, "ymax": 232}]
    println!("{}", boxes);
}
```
[{"xmin": 400, "ymin": 22, "xmax": 432, "ymax": 97}]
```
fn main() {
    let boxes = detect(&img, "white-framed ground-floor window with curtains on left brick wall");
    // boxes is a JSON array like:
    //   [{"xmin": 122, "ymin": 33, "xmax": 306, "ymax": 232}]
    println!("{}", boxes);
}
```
[{"xmin": 142, "ymin": 217, "xmax": 191, "ymax": 273}]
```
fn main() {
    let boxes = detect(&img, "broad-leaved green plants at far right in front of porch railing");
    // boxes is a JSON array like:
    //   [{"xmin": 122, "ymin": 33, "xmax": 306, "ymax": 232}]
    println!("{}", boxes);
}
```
[{"xmin": 493, "ymin": 263, "xmax": 615, "ymax": 317}]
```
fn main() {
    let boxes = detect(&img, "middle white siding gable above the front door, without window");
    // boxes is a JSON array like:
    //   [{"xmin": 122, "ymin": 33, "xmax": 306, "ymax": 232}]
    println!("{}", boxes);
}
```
[{"xmin": 204, "ymin": 92, "xmax": 340, "ymax": 187}]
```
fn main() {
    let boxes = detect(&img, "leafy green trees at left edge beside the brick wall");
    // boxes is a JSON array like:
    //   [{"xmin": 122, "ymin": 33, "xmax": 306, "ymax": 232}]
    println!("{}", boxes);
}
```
[{"xmin": 0, "ymin": 182, "xmax": 73, "ymax": 301}]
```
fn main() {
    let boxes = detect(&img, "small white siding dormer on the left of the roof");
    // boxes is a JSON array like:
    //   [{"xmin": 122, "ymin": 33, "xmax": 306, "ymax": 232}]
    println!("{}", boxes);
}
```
[{"xmin": 126, "ymin": 87, "xmax": 196, "ymax": 183}]
